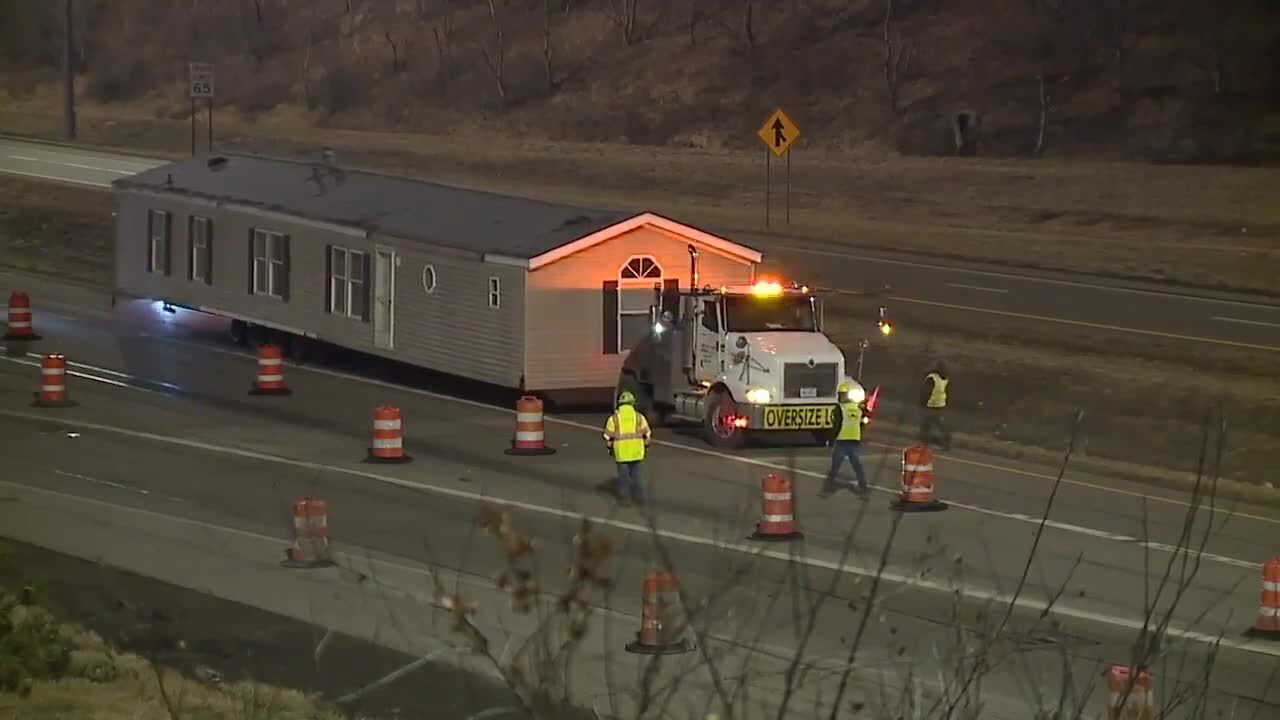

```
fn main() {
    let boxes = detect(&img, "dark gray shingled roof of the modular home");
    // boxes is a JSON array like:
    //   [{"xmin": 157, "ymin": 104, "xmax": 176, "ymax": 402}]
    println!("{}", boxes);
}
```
[{"xmin": 111, "ymin": 152, "xmax": 636, "ymax": 259}]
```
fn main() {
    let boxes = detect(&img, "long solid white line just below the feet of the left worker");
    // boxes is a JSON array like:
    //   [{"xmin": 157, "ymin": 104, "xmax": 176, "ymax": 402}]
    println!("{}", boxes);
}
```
[{"xmin": 0, "ymin": 410, "xmax": 1280, "ymax": 657}]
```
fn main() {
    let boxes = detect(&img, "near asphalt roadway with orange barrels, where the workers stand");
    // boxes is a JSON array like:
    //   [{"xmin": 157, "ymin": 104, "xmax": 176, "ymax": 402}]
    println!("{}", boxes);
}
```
[{"xmin": 0, "ymin": 274, "xmax": 1280, "ymax": 702}]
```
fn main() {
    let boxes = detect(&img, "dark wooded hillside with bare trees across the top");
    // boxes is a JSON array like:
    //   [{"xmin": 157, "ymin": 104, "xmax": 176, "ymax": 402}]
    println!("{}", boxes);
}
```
[{"xmin": 0, "ymin": 0, "xmax": 1280, "ymax": 163}]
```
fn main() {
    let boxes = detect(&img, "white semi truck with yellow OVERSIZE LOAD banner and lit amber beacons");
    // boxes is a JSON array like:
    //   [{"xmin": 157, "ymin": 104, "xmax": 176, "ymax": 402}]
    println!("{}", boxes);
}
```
[{"xmin": 616, "ymin": 247, "xmax": 892, "ymax": 447}]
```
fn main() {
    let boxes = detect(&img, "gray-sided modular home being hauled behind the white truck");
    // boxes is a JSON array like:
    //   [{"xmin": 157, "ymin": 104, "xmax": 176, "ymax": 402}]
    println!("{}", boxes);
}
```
[{"xmin": 113, "ymin": 152, "xmax": 760, "ymax": 393}]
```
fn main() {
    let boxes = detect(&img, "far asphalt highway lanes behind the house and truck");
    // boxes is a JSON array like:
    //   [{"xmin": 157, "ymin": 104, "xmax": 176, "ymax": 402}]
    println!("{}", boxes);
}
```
[{"xmin": 0, "ymin": 140, "xmax": 1280, "ymax": 352}]
